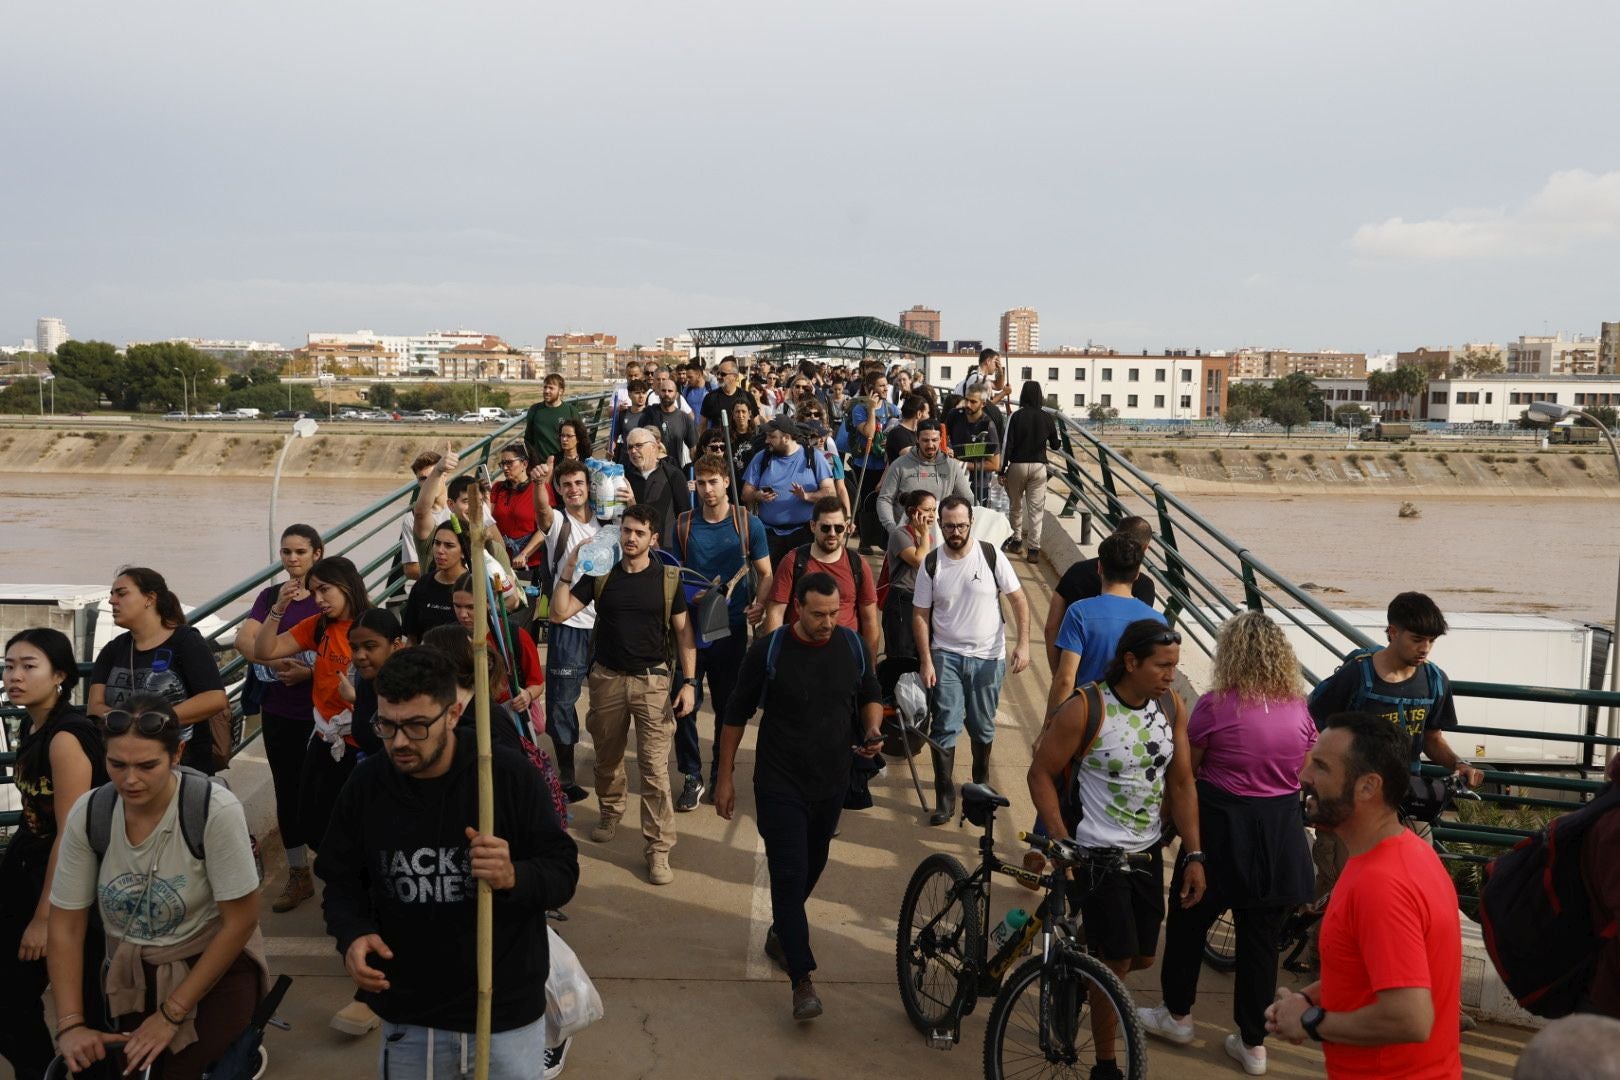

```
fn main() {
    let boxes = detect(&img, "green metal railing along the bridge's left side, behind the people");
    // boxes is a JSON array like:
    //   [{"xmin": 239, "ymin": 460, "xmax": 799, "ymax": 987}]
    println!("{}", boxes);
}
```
[{"xmin": 0, "ymin": 392, "xmax": 612, "ymax": 829}]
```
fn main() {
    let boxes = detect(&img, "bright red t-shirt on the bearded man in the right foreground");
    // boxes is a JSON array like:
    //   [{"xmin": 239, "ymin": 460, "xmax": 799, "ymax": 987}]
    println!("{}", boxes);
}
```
[{"xmin": 1320, "ymin": 829, "xmax": 1463, "ymax": 1080}]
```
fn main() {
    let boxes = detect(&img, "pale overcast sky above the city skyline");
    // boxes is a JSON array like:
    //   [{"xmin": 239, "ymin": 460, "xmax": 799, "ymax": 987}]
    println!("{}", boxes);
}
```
[{"xmin": 0, "ymin": 0, "xmax": 1620, "ymax": 351}]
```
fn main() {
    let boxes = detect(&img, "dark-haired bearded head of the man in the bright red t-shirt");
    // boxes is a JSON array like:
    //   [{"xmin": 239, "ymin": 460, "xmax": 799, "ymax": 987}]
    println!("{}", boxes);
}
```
[{"xmin": 1299, "ymin": 712, "xmax": 1411, "ymax": 831}]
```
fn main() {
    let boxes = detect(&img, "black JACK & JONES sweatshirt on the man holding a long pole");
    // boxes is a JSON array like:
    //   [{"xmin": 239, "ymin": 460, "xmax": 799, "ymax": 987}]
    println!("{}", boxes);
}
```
[{"xmin": 314, "ymin": 722, "xmax": 580, "ymax": 1031}]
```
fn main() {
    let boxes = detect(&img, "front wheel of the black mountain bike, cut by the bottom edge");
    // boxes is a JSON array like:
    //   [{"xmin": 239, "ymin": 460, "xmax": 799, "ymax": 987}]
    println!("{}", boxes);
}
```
[{"xmin": 985, "ymin": 950, "xmax": 1147, "ymax": 1080}]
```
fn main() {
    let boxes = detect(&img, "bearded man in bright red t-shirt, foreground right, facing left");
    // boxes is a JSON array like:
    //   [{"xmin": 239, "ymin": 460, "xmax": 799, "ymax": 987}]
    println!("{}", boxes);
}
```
[{"xmin": 1265, "ymin": 712, "xmax": 1463, "ymax": 1080}]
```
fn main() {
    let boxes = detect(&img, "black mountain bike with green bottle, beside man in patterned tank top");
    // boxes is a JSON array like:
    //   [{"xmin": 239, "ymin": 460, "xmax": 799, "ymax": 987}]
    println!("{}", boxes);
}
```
[{"xmin": 894, "ymin": 784, "xmax": 1149, "ymax": 1080}]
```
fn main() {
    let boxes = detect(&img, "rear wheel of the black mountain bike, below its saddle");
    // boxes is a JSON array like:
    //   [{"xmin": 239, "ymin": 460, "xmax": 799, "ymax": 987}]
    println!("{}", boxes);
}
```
[{"xmin": 894, "ymin": 855, "xmax": 982, "ymax": 1035}]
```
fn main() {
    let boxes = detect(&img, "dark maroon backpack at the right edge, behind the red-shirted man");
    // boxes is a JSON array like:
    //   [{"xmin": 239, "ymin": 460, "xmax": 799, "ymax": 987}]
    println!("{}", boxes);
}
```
[{"xmin": 1479, "ymin": 784, "xmax": 1620, "ymax": 1018}]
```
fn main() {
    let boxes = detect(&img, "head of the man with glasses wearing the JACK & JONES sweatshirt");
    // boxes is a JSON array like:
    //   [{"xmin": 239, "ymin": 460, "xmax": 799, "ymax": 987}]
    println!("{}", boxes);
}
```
[{"xmin": 371, "ymin": 646, "xmax": 462, "ymax": 779}]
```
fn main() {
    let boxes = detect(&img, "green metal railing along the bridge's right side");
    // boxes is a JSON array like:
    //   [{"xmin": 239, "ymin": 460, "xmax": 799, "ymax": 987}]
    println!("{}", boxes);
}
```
[{"xmin": 1048, "ymin": 410, "xmax": 1620, "ymax": 880}]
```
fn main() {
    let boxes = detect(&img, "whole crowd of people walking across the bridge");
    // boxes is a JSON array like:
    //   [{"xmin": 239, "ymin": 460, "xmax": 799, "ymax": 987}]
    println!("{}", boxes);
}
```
[{"xmin": 0, "ymin": 350, "xmax": 1620, "ymax": 1080}]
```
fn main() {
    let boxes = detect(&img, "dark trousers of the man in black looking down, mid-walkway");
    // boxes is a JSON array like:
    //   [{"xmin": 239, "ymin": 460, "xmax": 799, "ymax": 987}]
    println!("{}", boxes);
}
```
[{"xmin": 753, "ymin": 789, "xmax": 844, "ymax": 983}]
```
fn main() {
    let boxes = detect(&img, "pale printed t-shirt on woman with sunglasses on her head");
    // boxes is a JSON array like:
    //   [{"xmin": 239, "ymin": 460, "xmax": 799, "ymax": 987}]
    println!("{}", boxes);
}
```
[{"xmin": 50, "ymin": 782, "xmax": 259, "ymax": 946}]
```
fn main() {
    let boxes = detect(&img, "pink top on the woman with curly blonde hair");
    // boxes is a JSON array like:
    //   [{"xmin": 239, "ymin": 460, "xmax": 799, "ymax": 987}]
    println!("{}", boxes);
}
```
[{"xmin": 1187, "ymin": 690, "xmax": 1317, "ymax": 798}]
